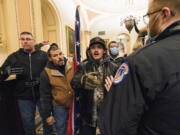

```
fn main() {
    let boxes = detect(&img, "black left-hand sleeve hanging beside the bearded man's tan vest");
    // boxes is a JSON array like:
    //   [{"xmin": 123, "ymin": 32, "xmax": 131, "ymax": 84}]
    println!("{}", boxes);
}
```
[{"xmin": 40, "ymin": 71, "xmax": 53, "ymax": 118}]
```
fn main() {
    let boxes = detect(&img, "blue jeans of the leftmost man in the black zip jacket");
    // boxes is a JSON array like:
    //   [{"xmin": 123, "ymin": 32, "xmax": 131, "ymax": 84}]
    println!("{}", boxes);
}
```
[{"xmin": 18, "ymin": 99, "xmax": 52, "ymax": 135}]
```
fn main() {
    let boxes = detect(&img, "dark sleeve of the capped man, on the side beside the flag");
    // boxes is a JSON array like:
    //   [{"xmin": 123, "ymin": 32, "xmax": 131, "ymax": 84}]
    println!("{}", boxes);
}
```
[{"xmin": 71, "ymin": 64, "xmax": 84, "ymax": 90}]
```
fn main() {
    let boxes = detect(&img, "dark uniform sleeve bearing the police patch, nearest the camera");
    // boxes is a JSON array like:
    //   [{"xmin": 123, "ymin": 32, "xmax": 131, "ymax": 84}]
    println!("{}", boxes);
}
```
[{"xmin": 100, "ymin": 60, "xmax": 145, "ymax": 135}]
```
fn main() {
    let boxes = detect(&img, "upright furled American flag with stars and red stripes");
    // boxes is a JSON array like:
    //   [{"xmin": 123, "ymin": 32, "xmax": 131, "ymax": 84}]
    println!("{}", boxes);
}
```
[{"xmin": 67, "ymin": 5, "xmax": 81, "ymax": 135}]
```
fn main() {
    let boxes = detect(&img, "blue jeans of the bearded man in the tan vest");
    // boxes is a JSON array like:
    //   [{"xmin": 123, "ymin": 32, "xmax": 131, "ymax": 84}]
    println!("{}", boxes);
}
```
[{"xmin": 53, "ymin": 106, "xmax": 68, "ymax": 135}]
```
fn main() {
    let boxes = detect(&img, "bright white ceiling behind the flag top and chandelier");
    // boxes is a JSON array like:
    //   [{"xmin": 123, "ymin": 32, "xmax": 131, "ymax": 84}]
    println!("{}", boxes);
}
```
[{"xmin": 53, "ymin": 0, "xmax": 148, "ymax": 41}]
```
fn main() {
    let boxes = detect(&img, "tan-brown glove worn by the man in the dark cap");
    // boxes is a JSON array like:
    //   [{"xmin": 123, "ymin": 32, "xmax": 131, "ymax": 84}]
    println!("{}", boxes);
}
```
[{"xmin": 81, "ymin": 72, "xmax": 102, "ymax": 90}]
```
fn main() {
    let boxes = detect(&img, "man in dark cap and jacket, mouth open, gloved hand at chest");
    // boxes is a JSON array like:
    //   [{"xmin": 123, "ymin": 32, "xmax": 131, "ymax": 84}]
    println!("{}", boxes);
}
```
[{"xmin": 71, "ymin": 37, "xmax": 117, "ymax": 135}]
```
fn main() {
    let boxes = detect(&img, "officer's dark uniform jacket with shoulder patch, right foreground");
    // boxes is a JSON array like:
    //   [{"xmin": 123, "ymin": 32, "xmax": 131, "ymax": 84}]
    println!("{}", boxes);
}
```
[{"xmin": 100, "ymin": 21, "xmax": 180, "ymax": 135}]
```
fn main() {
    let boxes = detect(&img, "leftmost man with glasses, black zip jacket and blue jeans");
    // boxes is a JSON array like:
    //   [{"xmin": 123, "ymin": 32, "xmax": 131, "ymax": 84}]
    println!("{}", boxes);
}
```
[{"xmin": 0, "ymin": 32, "xmax": 51, "ymax": 135}]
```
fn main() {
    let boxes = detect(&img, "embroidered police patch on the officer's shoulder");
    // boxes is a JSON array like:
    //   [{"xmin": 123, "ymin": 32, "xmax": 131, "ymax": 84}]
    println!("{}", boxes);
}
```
[{"xmin": 113, "ymin": 63, "xmax": 129, "ymax": 85}]
